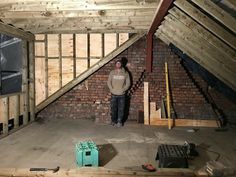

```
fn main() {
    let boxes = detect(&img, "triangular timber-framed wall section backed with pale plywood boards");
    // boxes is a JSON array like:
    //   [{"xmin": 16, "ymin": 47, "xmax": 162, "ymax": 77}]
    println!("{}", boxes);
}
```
[{"xmin": 35, "ymin": 33, "xmax": 129, "ymax": 108}]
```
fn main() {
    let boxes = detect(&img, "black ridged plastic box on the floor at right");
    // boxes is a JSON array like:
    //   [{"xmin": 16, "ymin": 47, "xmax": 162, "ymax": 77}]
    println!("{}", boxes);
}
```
[{"xmin": 156, "ymin": 144, "xmax": 188, "ymax": 168}]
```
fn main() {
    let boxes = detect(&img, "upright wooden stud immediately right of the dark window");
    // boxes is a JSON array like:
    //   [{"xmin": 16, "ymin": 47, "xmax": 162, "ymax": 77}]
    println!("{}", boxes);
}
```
[{"xmin": 22, "ymin": 41, "xmax": 29, "ymax": 125}]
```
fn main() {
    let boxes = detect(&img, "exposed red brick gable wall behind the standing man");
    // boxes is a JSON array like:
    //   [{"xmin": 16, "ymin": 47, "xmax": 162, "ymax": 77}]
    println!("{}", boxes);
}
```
[{"xmin": 39, "ymin": 38, "xmax": 215, "ymax": 122}]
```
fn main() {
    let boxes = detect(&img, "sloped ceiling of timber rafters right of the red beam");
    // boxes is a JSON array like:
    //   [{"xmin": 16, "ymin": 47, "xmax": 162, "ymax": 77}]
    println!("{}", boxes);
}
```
[{"xmin": 156, "ymin": 0, "xmax": 236, "ymax": 90}]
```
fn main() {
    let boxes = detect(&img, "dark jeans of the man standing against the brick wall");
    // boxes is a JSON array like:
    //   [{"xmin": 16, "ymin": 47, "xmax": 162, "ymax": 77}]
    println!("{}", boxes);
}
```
[{"xmin": 111, "ymin": 94, "xmax": 125, "ymax": 123}]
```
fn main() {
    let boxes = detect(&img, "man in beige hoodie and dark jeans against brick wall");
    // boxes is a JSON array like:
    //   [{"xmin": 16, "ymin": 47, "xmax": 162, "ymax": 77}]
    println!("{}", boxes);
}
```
[{"xmin": 107, "ymin": 60, "xmax": 130, "ymax": 127}]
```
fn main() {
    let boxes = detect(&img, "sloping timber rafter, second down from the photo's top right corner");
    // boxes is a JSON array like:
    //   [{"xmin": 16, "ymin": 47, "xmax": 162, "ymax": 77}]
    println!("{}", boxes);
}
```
[{"xmin": 191, "ymin": 0, "xmax": 236, "ymax": 33}]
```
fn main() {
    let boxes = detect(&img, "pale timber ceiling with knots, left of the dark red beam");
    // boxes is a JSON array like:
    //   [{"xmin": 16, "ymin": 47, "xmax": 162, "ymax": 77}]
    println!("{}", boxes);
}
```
[{"xmin": 0, "ymin": 0, "xmax": 159, "ymax": 33}]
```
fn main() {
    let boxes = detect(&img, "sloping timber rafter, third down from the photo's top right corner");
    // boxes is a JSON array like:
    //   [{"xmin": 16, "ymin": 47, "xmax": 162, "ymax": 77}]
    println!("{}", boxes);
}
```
[{"xmin": 174, "ymin": 0, "xmax": 236, "ymax": 50}]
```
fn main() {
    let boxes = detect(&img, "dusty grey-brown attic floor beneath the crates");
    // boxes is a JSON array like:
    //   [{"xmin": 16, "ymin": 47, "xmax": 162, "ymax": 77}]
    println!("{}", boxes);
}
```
[{"xmin": 0, "ymin": 119, "xmax": 236, "ymax": 170}]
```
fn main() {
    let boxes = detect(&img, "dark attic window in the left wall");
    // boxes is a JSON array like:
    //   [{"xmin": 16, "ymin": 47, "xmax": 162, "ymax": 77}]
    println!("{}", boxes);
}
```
[{"xmin": 0, "ymin": 34, "xmax": 22, "ymax": 95}]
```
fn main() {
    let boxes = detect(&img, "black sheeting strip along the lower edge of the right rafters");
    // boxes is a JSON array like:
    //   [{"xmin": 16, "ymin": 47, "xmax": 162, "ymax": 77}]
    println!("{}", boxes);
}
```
[{"xmin": 170, "ymin": 44, "xmax": 236, "ymax": 104}]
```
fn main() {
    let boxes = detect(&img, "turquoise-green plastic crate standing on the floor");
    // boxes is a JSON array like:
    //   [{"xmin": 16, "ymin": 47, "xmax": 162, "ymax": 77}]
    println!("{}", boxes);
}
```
[{"xmin": 75, "ymin": 141, "xmax": 98, "ymax": 167}]
